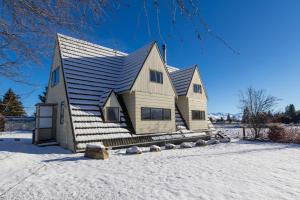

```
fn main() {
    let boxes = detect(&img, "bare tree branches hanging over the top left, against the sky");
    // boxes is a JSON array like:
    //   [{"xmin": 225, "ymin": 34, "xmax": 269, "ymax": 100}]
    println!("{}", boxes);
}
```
[{"xmin": 0, "ymin": 0, "xmax": 238, "ymax": 83}]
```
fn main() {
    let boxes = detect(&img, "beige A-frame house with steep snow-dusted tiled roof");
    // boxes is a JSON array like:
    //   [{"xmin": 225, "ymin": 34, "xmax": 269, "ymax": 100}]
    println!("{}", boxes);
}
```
[{"xmin": 36, "ymin": 34, "xmax": 209, "ymax": 151}]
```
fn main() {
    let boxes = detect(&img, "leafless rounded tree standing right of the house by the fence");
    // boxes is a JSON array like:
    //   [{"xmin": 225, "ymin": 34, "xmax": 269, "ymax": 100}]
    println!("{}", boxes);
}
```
[{"xmin": 240, "ymin": 87, "xmax": 279, "ymax": 139}]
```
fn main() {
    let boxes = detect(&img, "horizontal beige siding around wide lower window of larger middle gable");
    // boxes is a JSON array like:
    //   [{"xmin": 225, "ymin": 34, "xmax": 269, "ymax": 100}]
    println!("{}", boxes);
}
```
[{"xmin": 135, "ymin": 92, "xmax": 176, "ymax": 134}]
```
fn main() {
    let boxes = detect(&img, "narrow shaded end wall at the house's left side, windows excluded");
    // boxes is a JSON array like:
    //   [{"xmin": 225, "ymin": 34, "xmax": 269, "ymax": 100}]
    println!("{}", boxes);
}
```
[{"xmin": 46, "ymin": 45, "xmax": 74, "ymax": 151}]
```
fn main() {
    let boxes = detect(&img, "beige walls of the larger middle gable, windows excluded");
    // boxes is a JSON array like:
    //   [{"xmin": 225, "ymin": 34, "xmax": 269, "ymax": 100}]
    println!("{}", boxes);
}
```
[{"xmin": 128, "ymin": 45, "xmax": 176, "ymax": 134}]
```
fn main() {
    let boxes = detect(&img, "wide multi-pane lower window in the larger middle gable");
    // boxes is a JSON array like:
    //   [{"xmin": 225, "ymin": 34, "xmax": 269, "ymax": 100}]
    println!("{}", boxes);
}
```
[{"xmin": 141, "ymin": 108, "xmax": 171, "ymax": 120}]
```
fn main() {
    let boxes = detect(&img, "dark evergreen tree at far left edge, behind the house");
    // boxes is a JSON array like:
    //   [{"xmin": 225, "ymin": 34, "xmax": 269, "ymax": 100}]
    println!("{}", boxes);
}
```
[{"xmin": 2, "ymin": 88, "xmax": 26, "ymax": 116}]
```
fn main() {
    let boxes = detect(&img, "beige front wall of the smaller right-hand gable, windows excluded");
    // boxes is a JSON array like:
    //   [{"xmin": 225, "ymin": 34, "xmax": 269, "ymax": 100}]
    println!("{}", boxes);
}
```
[{"xmin": 187, "ymin": 70, "xmax": 208, "ymax": 130}]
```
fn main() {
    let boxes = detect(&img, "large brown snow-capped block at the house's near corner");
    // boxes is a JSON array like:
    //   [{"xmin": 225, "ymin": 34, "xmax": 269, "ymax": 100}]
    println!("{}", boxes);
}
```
[{"xmin": 84, "ymin": 144, "xmax": 109, "ymax": 160}]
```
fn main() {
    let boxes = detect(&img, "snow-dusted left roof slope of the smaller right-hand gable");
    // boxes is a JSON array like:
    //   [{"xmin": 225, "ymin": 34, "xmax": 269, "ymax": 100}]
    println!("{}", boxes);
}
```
[{"xmin": 170, "ymin": 65, "xmax": 197, "ymax": 96}]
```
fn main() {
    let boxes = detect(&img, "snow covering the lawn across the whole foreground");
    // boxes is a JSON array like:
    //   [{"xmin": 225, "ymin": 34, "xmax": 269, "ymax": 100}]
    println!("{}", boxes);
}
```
[{"xmin": 0, "ymin": 133, "xmax": 300, "ymax": 200}]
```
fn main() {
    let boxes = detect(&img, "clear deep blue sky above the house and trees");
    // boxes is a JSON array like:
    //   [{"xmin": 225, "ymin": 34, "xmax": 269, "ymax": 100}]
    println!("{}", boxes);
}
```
[{"xmin": 0, "ymin": 0, "xmax": 300, "ymax": 114}]
